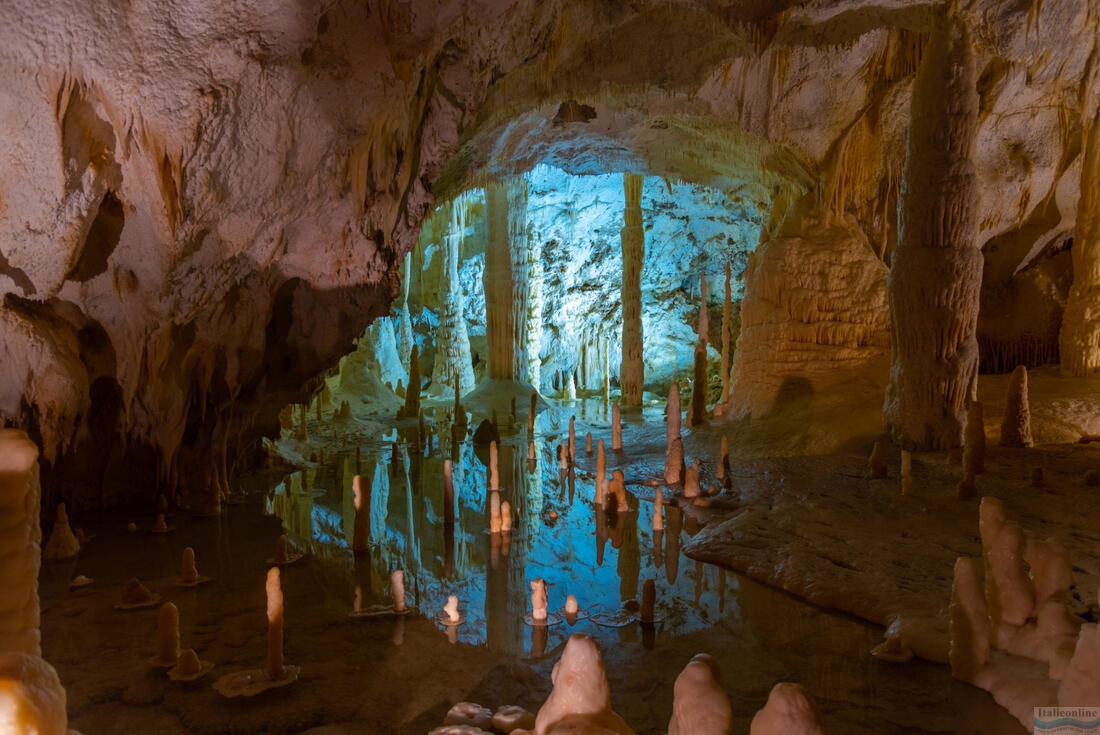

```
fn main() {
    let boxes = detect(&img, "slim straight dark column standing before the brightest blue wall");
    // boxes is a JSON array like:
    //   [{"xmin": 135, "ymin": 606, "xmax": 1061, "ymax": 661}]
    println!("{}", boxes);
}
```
[{"xmin": 619, "ymin": 174, "xmax": 646, "ymax": 406}]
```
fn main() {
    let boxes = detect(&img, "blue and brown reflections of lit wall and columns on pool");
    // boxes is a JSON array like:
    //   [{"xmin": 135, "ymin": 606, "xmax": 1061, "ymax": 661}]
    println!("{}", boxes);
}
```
[{"xmin": 267, "ymin": 402, "xmax": 737, "ymax": 658}]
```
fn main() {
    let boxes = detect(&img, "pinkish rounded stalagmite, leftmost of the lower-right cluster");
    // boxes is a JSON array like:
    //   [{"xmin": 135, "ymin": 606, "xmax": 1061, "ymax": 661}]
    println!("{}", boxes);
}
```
[{"xmin": 948, "ymin": 557, "xmax": 990, "ymax": 681}]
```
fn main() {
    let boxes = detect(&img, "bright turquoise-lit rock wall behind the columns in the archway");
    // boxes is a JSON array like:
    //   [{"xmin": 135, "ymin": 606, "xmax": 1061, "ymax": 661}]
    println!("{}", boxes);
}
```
[{"xmin": 400, "ymin": 165, "xmax": 762, "ymax": 394}]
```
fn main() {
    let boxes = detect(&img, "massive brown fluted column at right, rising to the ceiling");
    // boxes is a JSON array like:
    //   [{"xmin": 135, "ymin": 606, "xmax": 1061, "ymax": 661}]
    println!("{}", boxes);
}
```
[{"xmin": 883, "ymin": 11, "xmax": 983, "ymax": 450}]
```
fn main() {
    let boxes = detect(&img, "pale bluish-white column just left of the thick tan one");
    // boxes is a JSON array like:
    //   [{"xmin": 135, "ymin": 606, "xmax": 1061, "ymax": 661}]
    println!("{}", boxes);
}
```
[{"xmin": 431, "ymin": 191, "xmax": 475, "ymax": 395}]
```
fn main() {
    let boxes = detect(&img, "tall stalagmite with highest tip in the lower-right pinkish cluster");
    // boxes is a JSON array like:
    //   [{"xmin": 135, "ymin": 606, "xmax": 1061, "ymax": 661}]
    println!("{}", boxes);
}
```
[{"xmin": 979, "ymin": 497, "xmax": 1035, "ymax": 632}]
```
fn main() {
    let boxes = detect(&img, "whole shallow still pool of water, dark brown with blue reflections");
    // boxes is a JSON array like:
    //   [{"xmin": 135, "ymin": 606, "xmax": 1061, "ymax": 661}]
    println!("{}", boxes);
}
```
[{"xmin": 41, "ymin": 401, "xmax": 1023, "ymax": 735}]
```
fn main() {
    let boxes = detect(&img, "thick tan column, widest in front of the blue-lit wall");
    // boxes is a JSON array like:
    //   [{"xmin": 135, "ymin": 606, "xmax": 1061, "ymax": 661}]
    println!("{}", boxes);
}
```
[{"xmin": 483, "ymin": 176, "xmax": 530, "ymax": 381}]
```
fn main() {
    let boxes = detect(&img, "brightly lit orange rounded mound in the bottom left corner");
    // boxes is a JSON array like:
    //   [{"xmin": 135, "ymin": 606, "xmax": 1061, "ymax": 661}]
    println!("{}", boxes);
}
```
[{"xmin": 0, "ymin": 651, "xmax": 70, "ymax": 735}]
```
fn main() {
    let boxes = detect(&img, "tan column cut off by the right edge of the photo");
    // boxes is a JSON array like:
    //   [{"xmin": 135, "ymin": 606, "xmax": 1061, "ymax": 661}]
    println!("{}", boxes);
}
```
[{"xmin": 1058, "ymin": 113, "xmax": 1100, "ymax": 375}]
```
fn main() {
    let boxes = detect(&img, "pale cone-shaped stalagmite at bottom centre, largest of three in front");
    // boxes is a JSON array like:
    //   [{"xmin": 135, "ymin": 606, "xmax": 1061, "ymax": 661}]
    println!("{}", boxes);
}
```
[{"xmin": 534, "ymin": 634, "xmax": 634, "ymax": 735}]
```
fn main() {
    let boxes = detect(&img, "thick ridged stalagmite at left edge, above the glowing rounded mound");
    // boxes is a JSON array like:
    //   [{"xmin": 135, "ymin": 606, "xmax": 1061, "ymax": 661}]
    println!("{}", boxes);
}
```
[{"xmin": 0, "ymin": 429, "xmax": 41, "ymax": 655}]
